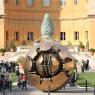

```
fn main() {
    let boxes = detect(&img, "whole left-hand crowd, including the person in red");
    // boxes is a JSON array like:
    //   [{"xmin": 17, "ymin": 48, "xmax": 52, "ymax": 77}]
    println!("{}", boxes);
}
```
[{"xmin": 0, "ymin": 60, "xmax": 27, "ymax": 92}]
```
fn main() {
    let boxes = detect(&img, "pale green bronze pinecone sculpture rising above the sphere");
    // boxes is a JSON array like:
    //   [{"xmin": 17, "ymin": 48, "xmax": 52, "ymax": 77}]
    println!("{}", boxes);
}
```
[{"xmin": 41, "ymin": 13, "xmax": 54, "ymax": 39}]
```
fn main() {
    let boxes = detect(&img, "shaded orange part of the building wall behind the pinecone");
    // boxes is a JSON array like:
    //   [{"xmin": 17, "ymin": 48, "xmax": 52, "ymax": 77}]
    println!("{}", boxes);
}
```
[{"xmin": 5, "ymin": 0, "xmax": 60, "ymax": 45}]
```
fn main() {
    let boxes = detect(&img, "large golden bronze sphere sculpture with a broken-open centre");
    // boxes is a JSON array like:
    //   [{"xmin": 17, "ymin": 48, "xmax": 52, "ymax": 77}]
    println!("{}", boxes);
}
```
[{"xmin": 23, "ymin": 40, "xmax": 75, "ymax": 91}]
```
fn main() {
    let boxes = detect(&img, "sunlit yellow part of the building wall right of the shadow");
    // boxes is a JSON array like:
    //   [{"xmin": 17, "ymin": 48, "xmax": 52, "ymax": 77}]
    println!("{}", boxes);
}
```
[{"xmin": 60, "ymin": 0, "xmax": 88, "ymax": 45}]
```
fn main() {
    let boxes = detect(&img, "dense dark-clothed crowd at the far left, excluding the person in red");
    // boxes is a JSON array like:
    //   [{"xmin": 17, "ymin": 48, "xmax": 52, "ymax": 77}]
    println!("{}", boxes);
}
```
[{"xmin": 0, "ymin": 60, "xmax": 16, "ymax": 92}]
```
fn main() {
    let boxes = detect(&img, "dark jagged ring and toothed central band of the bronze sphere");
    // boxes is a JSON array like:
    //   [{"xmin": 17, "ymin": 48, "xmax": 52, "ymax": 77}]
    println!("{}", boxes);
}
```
[{"xmin": 27, "ymin": 47, "xmax": 72, "ymax": 82}]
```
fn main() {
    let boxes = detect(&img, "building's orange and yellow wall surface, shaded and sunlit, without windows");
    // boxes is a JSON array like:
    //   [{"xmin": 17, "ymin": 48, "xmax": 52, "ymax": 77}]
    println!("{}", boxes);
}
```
[{"xmin": 2, "ymin": 0, "xmax": 95, "ymax": 47}]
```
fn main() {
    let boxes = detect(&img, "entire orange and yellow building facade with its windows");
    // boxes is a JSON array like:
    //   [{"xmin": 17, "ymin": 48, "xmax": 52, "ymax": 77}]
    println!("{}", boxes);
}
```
[{"xmin": 0, "ymin": 0, "xmax": 95, "ymax": 48}]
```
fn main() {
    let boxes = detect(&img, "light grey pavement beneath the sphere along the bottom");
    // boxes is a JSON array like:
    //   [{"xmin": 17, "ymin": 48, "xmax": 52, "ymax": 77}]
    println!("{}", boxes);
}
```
[{"xmin": 0, "ymin": 86, "xmax": 95, "ymax": 95}]
